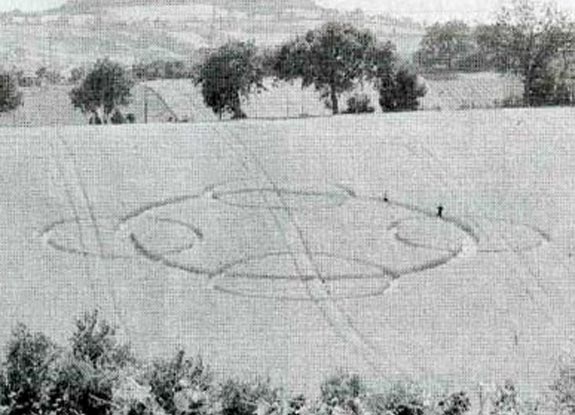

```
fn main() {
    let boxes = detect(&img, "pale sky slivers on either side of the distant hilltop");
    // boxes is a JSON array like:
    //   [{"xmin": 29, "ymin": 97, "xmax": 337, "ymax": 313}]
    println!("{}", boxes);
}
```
[{"xmin": 0, "ymin": 0, "xmax": 575, "ymax": 21}]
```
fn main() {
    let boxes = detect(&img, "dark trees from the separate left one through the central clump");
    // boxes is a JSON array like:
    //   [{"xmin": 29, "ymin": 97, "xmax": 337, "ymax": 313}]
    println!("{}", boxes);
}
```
[{"xmin": 65, "ymin": 23, "xmax": 425, "ymax": 124}]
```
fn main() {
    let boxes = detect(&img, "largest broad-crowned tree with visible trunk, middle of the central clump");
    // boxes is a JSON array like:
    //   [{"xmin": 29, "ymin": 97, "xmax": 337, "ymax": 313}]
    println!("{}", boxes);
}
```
[{"xmin": 274, "ymin": 22, "xmax": 377, "ymax": 114}]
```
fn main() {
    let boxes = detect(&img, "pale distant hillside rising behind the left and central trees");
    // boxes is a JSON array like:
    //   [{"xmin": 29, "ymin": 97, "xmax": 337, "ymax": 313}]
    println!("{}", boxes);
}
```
[{"xmin": 0, "ymin": 0, "xmax": 422, "ymax": 71}]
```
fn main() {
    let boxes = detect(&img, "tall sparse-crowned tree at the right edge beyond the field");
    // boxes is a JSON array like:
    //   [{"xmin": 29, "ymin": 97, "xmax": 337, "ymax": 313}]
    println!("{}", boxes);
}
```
[{"xmin": 481, "ymin": 0, "xmax": 575, "ymax": 106}]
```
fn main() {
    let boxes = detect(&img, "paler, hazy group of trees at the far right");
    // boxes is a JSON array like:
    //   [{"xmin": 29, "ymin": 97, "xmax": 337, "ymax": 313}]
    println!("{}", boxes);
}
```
[{"xmin": 414, "ymin": 0, "xmax": 575, "ymax": 106}]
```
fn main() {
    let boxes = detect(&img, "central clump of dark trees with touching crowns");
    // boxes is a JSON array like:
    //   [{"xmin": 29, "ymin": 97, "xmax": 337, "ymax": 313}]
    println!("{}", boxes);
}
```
[{"xmin": 195, "ymin": 22, "xmax": 425, "ymax": 118}]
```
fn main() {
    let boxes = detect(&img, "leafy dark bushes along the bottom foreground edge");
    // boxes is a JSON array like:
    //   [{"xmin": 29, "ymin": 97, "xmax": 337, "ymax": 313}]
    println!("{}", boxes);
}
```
[{"xmin": 0, "ymin": 312, "xmax": 575, "ymax": 415}]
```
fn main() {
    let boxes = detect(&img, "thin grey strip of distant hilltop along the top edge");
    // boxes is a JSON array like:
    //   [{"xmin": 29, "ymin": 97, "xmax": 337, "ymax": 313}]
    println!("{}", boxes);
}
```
[{"xmin": 59, "ymin": 0, "xmax": 321, "ymax": 13}]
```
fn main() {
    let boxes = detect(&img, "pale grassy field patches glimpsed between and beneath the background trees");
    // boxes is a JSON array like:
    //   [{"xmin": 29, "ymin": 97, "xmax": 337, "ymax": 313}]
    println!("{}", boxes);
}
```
[{"xmin": 0, "ymin": 73, "xmax": 521, "ymax": 127}]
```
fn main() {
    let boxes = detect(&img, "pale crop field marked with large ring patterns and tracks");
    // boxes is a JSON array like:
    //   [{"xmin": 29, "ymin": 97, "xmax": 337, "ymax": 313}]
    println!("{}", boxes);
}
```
[{"xmin": 0, "ymin": 109, "xmax": 575, "ymax": 398}]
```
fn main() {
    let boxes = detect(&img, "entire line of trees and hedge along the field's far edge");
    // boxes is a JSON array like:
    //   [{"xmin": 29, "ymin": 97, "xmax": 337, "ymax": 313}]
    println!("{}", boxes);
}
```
[{"xmin": 0, "ymin": 0, "xmax": 575, "ymax": 124}]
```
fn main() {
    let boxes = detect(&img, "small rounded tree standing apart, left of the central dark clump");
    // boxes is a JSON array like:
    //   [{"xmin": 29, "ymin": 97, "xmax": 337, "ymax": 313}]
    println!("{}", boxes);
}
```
[{"xmin": 70, "ymin": 59, "xmax": 134, "ymax": 124}]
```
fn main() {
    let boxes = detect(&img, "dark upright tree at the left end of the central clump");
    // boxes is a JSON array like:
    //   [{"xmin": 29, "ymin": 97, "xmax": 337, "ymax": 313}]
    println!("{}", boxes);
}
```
[{"xmin": 195, "ymin": 42, "xmax": 264, "ymax": 119}]
